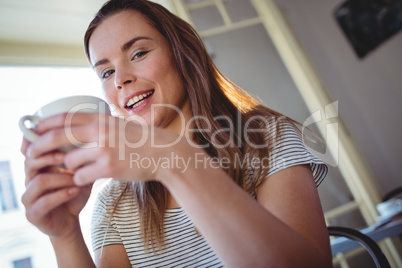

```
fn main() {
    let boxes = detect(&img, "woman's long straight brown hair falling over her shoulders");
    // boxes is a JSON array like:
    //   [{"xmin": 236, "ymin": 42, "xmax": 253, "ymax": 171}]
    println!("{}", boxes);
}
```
[{"xmin": 84, "ymin": 0, "xmax": 293, "ymax": 249}]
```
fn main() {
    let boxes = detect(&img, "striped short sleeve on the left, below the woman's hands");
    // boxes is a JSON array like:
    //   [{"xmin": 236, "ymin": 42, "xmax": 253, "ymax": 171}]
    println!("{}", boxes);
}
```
[{"xmin": 91, "ymin": 181, "xmax": 123, "ymax": 250}]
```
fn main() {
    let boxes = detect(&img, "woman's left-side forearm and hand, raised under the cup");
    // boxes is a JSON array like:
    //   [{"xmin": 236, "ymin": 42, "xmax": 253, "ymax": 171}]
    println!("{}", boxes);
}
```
[{"xmin": 21, "ymin": 139, "xmax": 95, "ymax": 268}]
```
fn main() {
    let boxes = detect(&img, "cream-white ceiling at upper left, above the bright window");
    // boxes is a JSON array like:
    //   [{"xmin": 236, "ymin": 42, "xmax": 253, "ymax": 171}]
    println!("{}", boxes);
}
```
[{"xmin": 0, "ymin": 0, "xmax": 176, "ymax": 65}]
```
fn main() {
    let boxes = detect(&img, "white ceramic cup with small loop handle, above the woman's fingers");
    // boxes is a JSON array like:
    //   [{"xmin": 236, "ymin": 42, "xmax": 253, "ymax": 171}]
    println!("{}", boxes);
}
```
[{"xmin": 19, "ymin": 95, "xmax": 111, "ymax": 142}]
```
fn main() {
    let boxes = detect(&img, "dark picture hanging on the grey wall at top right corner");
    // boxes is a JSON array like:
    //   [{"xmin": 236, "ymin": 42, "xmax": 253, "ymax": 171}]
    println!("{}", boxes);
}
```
[{"xmin": 334, "ymin": 0, "xmax": 402, "ymax": 58}]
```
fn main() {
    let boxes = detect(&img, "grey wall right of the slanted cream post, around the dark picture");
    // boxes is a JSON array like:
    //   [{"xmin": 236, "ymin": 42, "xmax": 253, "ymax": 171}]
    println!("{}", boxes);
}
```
[{"xmin": 276, "ymin": 0, "xmax": 402, "ymax": 194}]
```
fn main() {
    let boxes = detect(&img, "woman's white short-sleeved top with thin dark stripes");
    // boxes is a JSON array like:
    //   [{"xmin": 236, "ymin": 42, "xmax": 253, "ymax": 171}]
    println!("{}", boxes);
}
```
[{"xmin": 91, "ymin": 120, "xmax": 327, "ymax": 267}]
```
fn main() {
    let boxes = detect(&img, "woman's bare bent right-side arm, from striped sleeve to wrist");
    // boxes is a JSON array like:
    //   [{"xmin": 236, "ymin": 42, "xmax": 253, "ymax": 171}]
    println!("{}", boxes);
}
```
[{"xmin": 160, "ymin": 150, "xmax": 332, "ymax": 267}]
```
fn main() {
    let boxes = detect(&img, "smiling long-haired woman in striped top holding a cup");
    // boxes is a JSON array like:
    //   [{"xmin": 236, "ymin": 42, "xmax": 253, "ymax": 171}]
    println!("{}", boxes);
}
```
[{"xmin": 22, "ymin": 0, "xmax": 331, "ymax": 267}]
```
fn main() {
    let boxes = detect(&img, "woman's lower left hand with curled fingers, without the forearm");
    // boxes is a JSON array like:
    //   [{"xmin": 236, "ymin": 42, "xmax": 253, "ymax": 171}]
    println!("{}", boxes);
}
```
[{"xmin": 21, "ymin": 139, "xmax": 91, "ymax": 239}]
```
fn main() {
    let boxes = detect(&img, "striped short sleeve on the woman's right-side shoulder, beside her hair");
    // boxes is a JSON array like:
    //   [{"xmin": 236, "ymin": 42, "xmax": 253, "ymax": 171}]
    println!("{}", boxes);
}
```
[{"xmin": 266, "ymin": 120, "xmax": 328, "ymax": 186}]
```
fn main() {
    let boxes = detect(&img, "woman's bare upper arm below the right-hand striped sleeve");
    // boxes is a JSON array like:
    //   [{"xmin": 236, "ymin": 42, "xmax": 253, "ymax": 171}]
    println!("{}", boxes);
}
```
[{"xmin": 257, "ymin": 165, "xmax": 332, "ymax": 267}]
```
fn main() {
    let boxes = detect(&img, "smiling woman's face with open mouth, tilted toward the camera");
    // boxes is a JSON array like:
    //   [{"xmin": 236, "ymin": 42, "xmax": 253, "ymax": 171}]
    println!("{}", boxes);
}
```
[{"xmin": 89, "ymin": 10, "xmax": 191, "ymax": 131}]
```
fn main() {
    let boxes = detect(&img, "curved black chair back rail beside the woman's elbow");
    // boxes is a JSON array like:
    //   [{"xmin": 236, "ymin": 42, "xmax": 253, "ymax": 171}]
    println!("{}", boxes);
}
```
[{"xmin": 328, "ymin": 226, "xmax": 391, "ymax": 268}]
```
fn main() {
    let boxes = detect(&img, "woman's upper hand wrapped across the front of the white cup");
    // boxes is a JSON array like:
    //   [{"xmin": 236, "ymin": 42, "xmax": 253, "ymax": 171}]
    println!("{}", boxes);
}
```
[{"xmin": 27, "ymin": 113, "xmax": 179, "ymax": 185}]
